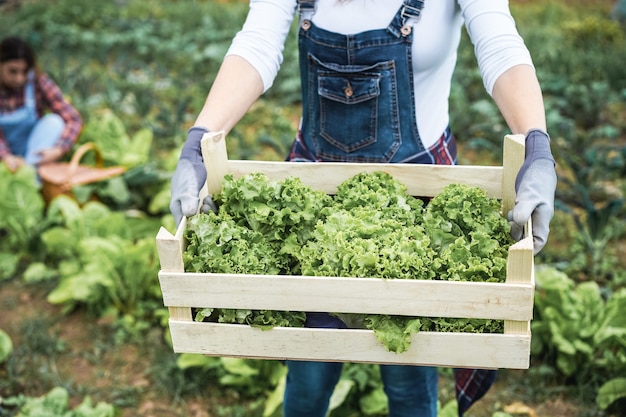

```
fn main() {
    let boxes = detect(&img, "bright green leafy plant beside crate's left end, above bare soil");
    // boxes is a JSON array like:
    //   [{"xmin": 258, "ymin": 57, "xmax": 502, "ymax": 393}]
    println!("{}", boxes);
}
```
[{"xmin": 36, "ymin": 196, "xmax": 161, "ymax": 327}]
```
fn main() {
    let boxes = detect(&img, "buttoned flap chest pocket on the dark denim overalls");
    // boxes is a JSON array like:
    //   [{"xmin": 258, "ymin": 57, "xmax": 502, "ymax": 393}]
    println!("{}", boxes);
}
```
[{"xmin": 309, "ymin": 55, "xmax": 401, "ymax": 162}]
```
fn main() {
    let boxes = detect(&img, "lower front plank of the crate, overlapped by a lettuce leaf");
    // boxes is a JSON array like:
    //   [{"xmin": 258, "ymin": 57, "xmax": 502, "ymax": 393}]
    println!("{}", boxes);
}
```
[{"xmin": 170, "ymin": 320, "xmax": 530, "ymax": 369}]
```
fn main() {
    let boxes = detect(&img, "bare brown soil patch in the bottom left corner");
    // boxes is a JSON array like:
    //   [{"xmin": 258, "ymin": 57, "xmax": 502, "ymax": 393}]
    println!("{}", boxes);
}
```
[{"xmin": 0, "ymin": 280, "xmax": 210, "ymax": 417}]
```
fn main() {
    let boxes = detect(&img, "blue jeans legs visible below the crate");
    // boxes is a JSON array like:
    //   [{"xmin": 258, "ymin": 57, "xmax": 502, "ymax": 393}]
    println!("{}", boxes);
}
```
[{"xmin": 283, "ymin": 361, "xmax": 438, "ymax": 417}]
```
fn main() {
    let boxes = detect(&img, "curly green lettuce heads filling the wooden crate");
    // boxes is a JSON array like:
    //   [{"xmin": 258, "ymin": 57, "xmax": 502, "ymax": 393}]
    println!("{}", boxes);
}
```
[{"xmin": 184, "ymin": 172, "xmax": 512, "ymax": 353}]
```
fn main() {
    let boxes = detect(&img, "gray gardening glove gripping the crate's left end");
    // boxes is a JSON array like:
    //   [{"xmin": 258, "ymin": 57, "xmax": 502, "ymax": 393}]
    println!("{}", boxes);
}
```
[{"xmin": 170, "ymin": 126, "xmax": 217, "ymax": 225}]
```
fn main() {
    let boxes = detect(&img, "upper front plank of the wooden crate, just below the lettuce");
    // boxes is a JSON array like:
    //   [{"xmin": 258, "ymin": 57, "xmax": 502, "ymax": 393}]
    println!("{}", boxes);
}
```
[{"xmin": 159, "ymin": 272, "xmax": 534, "ymax": 321}]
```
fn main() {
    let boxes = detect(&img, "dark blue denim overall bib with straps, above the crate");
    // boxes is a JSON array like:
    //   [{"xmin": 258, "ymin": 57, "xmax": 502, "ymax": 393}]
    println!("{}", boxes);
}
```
[{"xmin": 289, "ymin": 0, "xmax": 456, "ymax": 164}]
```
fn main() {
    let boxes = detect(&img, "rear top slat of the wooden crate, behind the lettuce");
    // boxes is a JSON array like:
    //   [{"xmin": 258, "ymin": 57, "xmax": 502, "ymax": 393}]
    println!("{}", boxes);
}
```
[{"xmin": 228, "ymin": 160, "xmax": 502, "ymax": 198}]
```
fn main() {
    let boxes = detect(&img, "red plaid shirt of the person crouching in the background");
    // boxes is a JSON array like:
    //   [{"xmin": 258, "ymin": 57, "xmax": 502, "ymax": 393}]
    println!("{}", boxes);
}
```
[{"xmin": 0, "ymin": 73, "xmax": 83, "ymax": 158}]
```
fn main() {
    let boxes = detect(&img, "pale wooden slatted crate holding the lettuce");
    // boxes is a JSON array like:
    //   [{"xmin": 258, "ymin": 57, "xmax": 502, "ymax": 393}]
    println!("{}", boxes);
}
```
[{"xmin": 156, "ymin": 133, "xmax": 534, "ymax": 369}]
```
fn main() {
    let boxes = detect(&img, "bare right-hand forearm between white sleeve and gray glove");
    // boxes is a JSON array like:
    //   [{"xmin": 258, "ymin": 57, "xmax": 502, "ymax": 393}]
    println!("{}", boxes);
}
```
[{"xmin": 492, "ymin": 65, "xmax": 546, "ymax": 134}]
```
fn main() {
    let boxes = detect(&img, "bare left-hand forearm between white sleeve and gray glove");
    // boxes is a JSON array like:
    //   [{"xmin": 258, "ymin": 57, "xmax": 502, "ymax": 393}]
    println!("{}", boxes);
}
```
[{"xmin": 195, "ymin": 55, "xmax": 263, "ymax": 133}]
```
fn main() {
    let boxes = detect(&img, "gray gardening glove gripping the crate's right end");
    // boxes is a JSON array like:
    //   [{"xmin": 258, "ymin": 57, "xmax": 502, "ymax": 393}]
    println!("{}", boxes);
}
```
[{"xmin": 508, "ymin": 129, "xmax": 556, "ymax": 255}]
